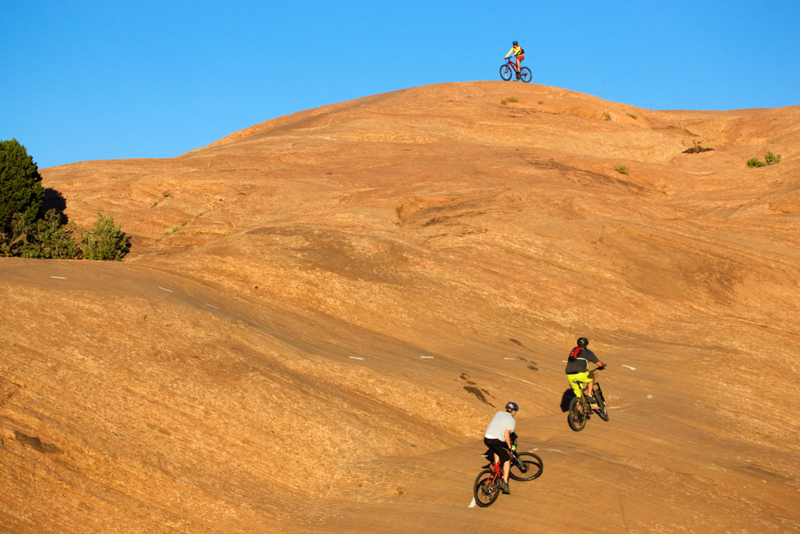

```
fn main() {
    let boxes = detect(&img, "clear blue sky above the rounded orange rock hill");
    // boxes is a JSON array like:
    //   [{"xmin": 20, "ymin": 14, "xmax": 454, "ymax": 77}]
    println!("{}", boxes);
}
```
[{"xmin": 0, "ymin": 0, "xmax": 800, "ymax": 168}]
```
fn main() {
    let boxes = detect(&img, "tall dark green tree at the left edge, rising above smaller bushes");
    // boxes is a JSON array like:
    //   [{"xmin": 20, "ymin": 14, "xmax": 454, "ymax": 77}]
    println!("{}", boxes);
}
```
[{"xmin": 0, "ymin": 139, "xmax": 44, "ymax": 234}]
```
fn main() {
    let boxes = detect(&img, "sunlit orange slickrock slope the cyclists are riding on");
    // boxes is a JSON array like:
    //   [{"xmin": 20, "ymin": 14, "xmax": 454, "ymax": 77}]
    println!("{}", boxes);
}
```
[{"xmin": 0, "ymin": 82, "xmax": 800, "ymax": 533}]
